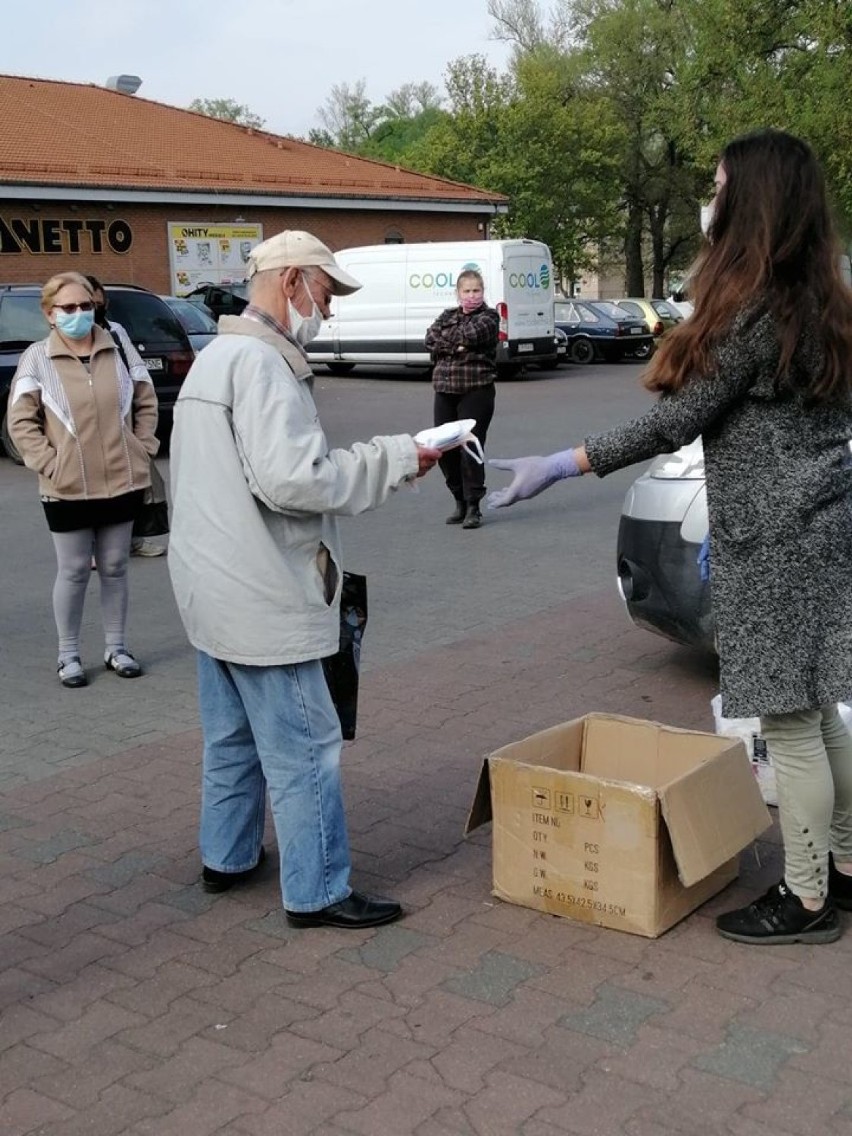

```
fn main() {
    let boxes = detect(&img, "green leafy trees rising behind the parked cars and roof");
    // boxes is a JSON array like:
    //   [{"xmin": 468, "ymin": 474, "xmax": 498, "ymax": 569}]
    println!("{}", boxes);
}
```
[{"xmin": 310, "ymin": 0, "xmax": 852, "ymax": 281}]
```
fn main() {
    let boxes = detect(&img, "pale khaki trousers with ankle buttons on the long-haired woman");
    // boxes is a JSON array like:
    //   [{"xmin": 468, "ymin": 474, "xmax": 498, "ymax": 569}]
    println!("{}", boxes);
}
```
[{"xmin": 760, "ymin": 704, "xmax": 852, "ymax": 900}]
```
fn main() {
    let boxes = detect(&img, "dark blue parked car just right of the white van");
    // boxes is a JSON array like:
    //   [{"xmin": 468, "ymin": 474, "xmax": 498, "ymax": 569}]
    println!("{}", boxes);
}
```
[{"xmin": 554, "ymin": 299, "xmax": 653, "ymax": 362}]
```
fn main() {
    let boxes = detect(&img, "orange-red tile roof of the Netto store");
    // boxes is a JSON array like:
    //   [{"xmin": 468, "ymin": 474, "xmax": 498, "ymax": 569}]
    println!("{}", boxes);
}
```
[{"xmin": 0, "ymin": 75, "xmax": 506, "ymax": 206}]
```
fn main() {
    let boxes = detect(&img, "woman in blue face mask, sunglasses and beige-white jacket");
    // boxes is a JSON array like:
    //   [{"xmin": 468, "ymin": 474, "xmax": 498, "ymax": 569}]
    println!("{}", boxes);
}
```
[{"xmin": 8, "ymin": 273, "xmax": 159, "ymax": 687}]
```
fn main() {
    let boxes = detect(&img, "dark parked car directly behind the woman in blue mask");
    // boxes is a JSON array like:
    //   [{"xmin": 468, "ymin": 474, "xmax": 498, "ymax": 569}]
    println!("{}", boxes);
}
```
[{"xmin": 0, "ymin": 284, "xmax": 195, "ymax": 461}]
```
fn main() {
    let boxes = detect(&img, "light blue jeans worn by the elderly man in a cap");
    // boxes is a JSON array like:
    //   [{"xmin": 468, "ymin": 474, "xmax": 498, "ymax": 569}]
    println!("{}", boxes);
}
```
[{"xmin": 198, "ymin": 651, "xmax": 352, "ymax": 911}]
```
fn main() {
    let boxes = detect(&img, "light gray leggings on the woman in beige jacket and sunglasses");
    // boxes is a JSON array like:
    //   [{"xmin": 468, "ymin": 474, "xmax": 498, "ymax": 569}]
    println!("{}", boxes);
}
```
[{"xmin": 50, "ymin": 520, "xmax": 133, "ymax": 660}]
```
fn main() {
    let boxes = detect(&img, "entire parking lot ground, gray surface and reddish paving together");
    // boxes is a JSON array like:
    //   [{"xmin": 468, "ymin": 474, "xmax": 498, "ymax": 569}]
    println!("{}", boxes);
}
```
[{"xmin": 0, "ymin": 364, "xmax": 852, "ymax": 1136}]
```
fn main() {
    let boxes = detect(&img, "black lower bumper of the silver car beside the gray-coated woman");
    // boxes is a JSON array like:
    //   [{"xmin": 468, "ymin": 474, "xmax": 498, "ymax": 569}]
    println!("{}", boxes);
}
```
[{"xmin": 618, "ymin": 516, "xmax": 715, "ymax": 651}]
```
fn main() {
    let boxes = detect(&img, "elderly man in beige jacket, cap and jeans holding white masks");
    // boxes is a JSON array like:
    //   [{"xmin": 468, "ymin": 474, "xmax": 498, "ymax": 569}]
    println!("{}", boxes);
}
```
[{"xmin": 169, "ymin": 231, "xmax": 440, "ymax": 927}]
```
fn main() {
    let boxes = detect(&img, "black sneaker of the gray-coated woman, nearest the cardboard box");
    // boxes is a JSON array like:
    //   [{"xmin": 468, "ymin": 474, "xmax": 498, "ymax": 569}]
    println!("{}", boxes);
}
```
[{"xmin": 716, "ymin": 880, "xmax": 841, "ymax": 946}]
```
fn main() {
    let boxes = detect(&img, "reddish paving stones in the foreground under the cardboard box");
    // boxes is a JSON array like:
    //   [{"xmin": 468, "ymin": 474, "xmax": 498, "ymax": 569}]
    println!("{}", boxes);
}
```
[{"xmin": 0, "ymin": 588, "xmax": 852, "ymax": 1136}]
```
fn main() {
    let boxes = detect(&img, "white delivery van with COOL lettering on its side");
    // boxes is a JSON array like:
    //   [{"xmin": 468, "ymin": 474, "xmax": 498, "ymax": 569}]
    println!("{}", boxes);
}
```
[{"xmin": 308, "ymin": 239, "xmax": 556, "ymax": 375}]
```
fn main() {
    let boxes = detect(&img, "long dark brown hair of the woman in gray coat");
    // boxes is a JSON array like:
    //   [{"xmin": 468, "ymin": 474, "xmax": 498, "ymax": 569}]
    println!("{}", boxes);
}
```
[{"xmin": 645, "ymin": 130, "xmax": 852, "ymax": 401}]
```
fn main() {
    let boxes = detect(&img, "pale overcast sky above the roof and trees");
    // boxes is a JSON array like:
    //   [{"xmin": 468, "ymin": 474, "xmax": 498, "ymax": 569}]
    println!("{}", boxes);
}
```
[{"xmin": 0, "ymin": 0, "xmax": 509, "ymax": 136}]
